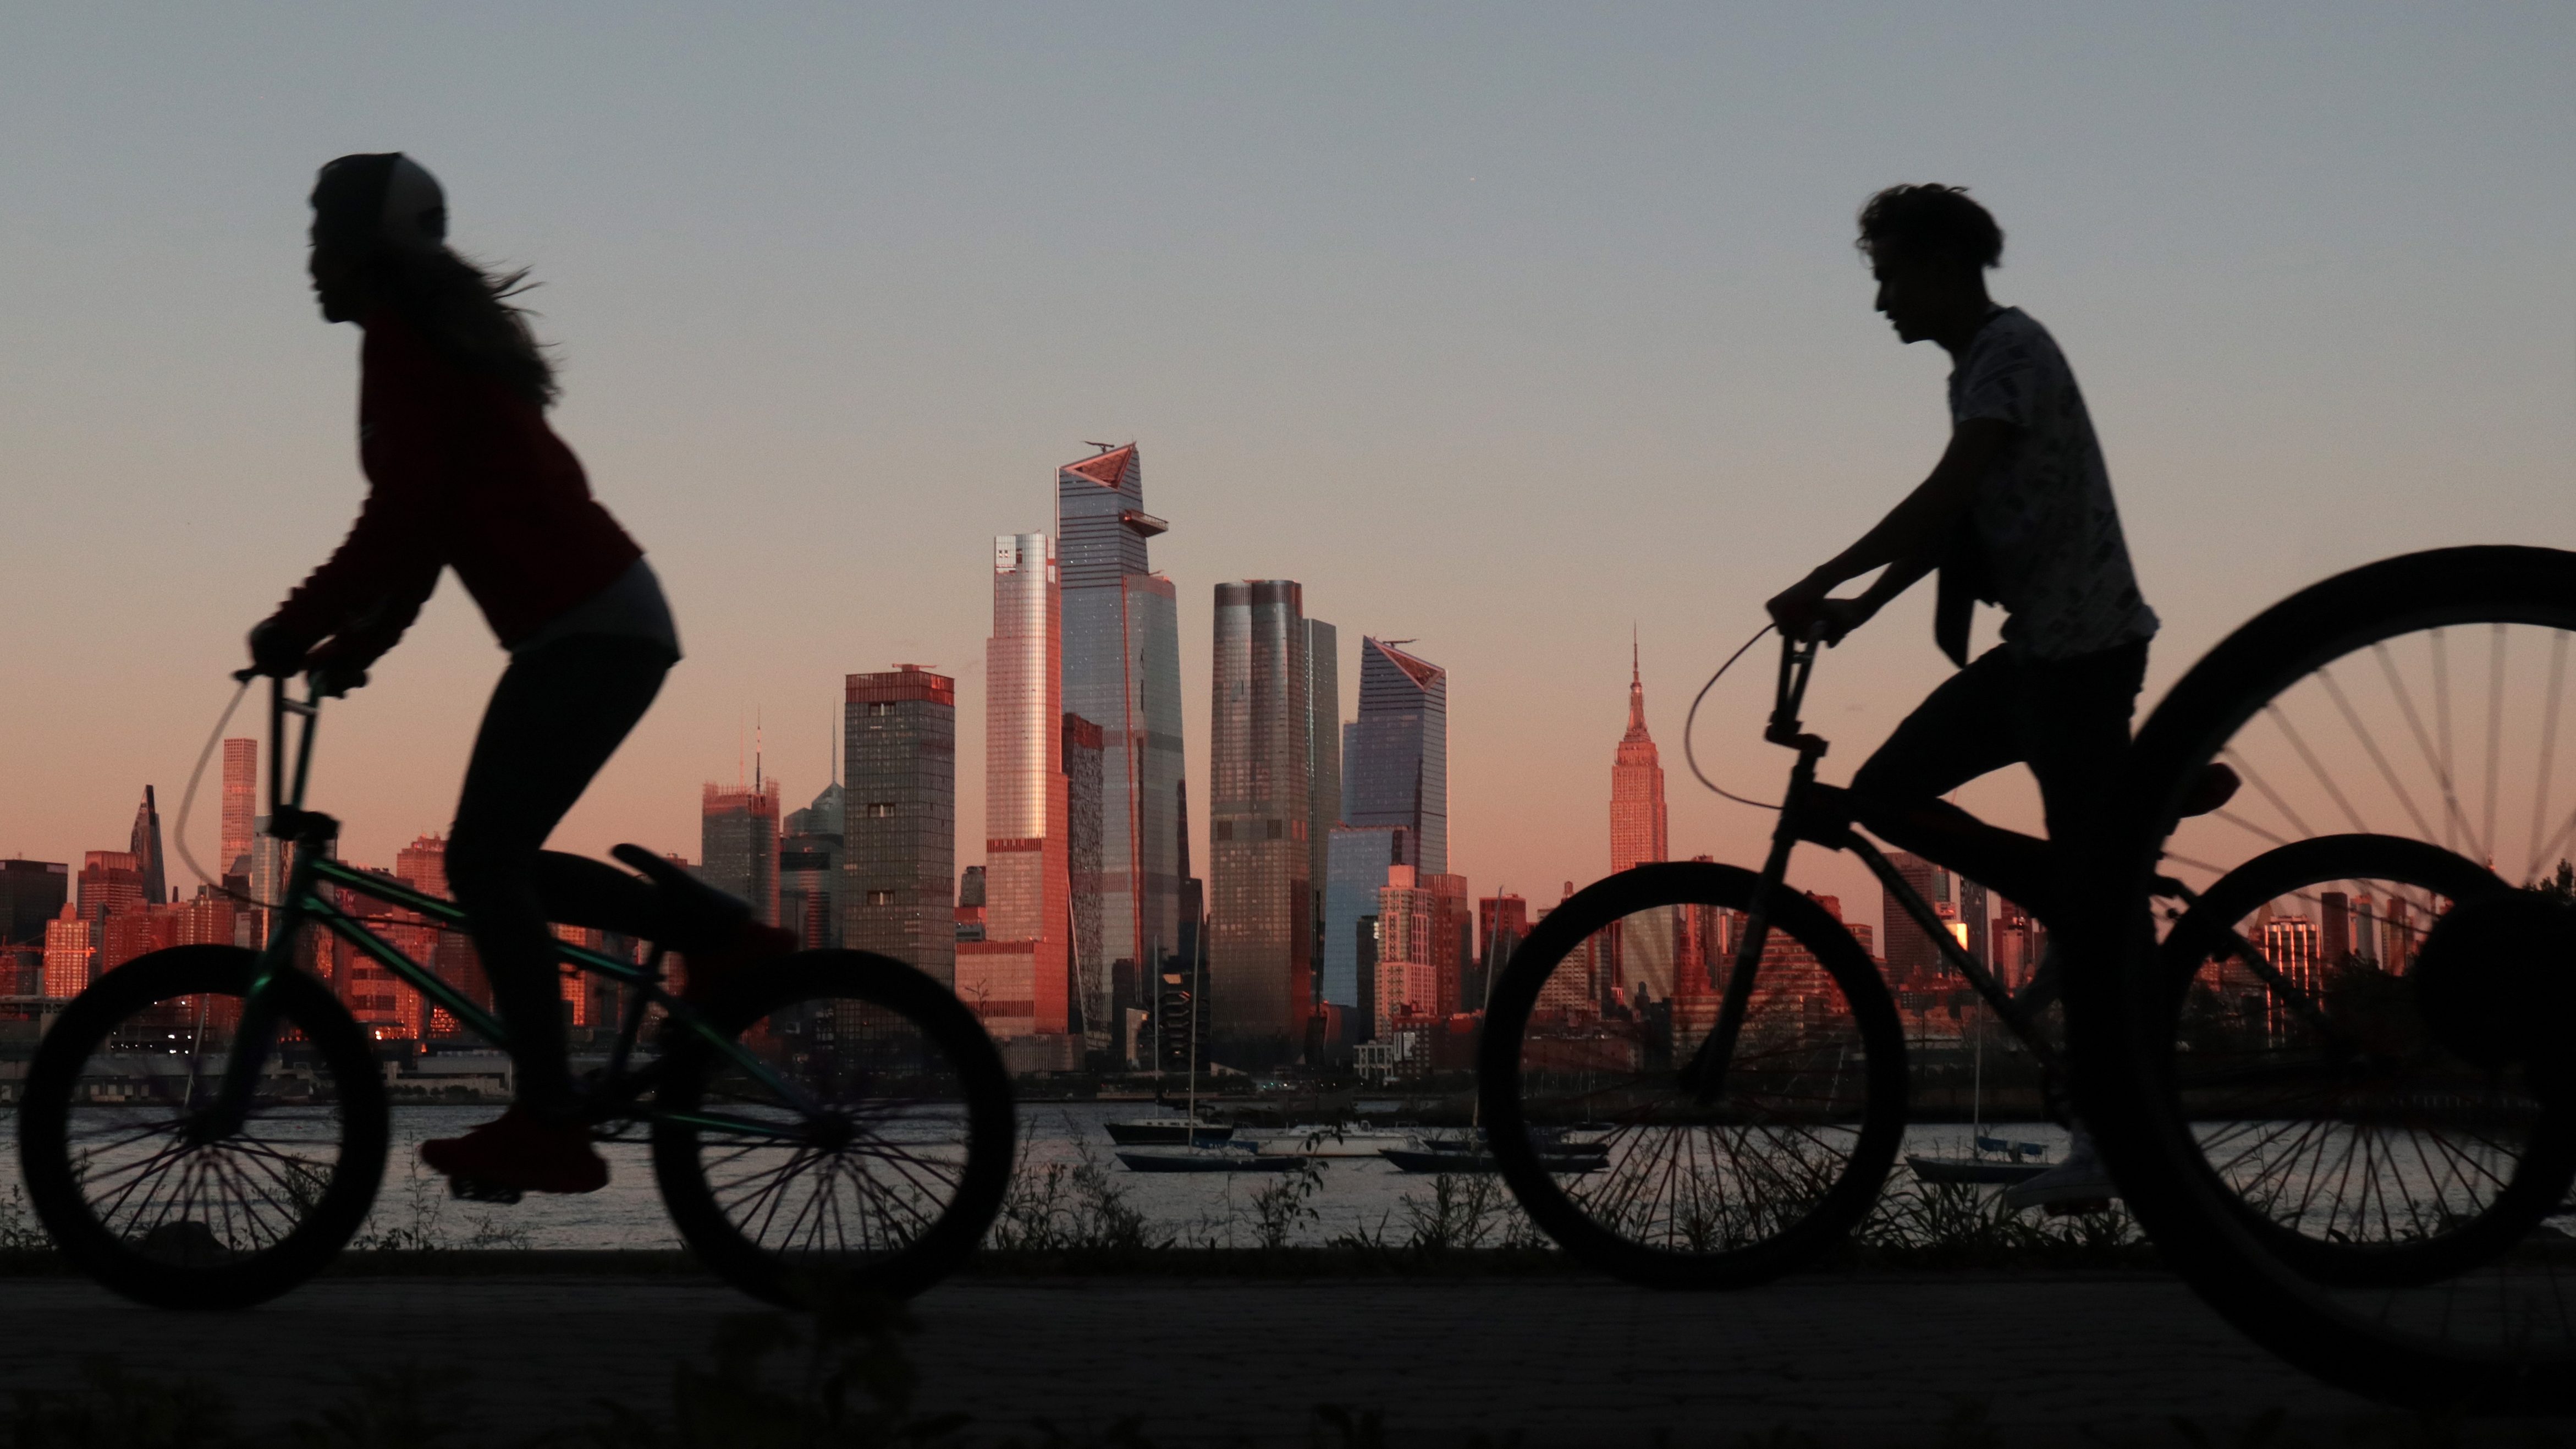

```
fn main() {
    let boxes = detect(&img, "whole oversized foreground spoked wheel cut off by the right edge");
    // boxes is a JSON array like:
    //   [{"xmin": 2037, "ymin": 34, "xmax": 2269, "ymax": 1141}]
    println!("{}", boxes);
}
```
[{"xmin": 2068, "ymin": 547, "xmax": 2576, "ymax": 1413}]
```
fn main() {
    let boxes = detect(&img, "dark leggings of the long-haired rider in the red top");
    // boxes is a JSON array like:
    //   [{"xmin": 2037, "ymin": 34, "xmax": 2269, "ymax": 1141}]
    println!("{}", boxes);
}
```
[{"xmin": 448, "ymin": 634, "xmax": 703, "ymax": 1119}]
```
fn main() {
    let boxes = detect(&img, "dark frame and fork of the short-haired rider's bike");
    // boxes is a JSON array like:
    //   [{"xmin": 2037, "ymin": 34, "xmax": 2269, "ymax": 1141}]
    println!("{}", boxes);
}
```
[{"xmin": 1682, "ymin": 637, "xmax": 2058, "ymax": 1104}]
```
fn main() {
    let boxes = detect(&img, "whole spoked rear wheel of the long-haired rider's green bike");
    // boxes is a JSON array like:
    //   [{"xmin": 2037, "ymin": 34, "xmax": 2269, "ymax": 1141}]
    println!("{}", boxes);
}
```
[{"xmin": 652, "ymin": 951, "xmax": 1012, "ymax": 1307}]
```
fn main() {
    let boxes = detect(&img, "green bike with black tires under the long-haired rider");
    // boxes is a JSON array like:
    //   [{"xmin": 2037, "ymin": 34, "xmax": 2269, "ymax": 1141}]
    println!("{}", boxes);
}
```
[{"xmin": 18, "ymin": 671, "xmax": 1015, "ymax": 1307}]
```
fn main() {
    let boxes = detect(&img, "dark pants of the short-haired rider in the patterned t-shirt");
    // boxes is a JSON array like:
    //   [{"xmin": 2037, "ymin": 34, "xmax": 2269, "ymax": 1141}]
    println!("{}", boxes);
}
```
[{"xmin": 1852, "ymin": 639, "xmax": 2146, "ymax": 926}]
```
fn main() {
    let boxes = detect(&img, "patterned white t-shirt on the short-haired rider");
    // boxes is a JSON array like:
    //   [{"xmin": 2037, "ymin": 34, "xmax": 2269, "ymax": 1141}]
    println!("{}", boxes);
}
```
[{"xmin": 1950, "ymin": 307, "xmax": 2156, "ymax": 660}]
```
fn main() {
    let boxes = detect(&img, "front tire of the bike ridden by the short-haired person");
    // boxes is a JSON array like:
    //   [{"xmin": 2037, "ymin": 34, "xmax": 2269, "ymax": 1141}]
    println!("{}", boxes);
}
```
[{"xmin": 1476, "ymin": 861, "xmax": 1906, "ymax": 1289}]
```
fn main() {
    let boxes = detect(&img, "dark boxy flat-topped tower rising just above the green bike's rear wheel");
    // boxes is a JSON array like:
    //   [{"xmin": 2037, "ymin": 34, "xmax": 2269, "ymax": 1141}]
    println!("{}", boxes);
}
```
[{"xmin": 843, "ymin": 665, "xmax": 958, "ymax": 985}]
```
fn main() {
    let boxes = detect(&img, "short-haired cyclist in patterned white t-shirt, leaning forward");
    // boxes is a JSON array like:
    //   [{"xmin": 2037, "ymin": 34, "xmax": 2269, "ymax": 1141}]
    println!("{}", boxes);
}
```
[{"xmin": 1770, "ymin": 185, "xmax": 2215, "ymax": 1206}]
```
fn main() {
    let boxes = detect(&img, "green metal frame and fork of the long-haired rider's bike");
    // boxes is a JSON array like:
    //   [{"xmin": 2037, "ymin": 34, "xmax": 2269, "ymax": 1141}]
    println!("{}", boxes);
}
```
[{"xmin": 199, "ymin": 678, "xmax": 822, "ymax": 1140}]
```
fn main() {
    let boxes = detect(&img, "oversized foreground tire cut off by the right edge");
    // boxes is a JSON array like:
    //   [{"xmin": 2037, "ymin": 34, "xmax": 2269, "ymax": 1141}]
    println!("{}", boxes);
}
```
[{"xmin": 2066, "ymin": 547, "xmax": 2576, "ymax": 1413}]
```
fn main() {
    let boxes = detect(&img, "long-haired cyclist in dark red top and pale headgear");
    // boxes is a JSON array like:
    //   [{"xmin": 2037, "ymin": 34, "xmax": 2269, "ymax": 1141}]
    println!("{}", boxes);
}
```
[{"xmin": 250, "ymin": 152, "xmax": 794, "ymax": 1191}]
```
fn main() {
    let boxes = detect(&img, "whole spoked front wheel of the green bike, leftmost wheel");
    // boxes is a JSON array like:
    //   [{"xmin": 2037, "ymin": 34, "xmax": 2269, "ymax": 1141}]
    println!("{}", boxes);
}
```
[{"xmin": 18, "ymin": 946, "xmax": 389, "ymax": 1307}]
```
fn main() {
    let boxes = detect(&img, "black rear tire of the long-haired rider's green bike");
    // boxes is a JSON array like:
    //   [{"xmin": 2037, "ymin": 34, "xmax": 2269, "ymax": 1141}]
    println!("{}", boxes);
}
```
[{"xmin": 652, "ymin": 951, "xmax": 1015, "ymax": 1307}]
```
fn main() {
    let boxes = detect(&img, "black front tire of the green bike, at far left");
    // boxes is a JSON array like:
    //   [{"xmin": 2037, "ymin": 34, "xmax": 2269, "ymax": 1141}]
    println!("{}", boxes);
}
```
[{"xmin": 18, "ymin": 946, "xmax": 392, "ymax": 1310}]
